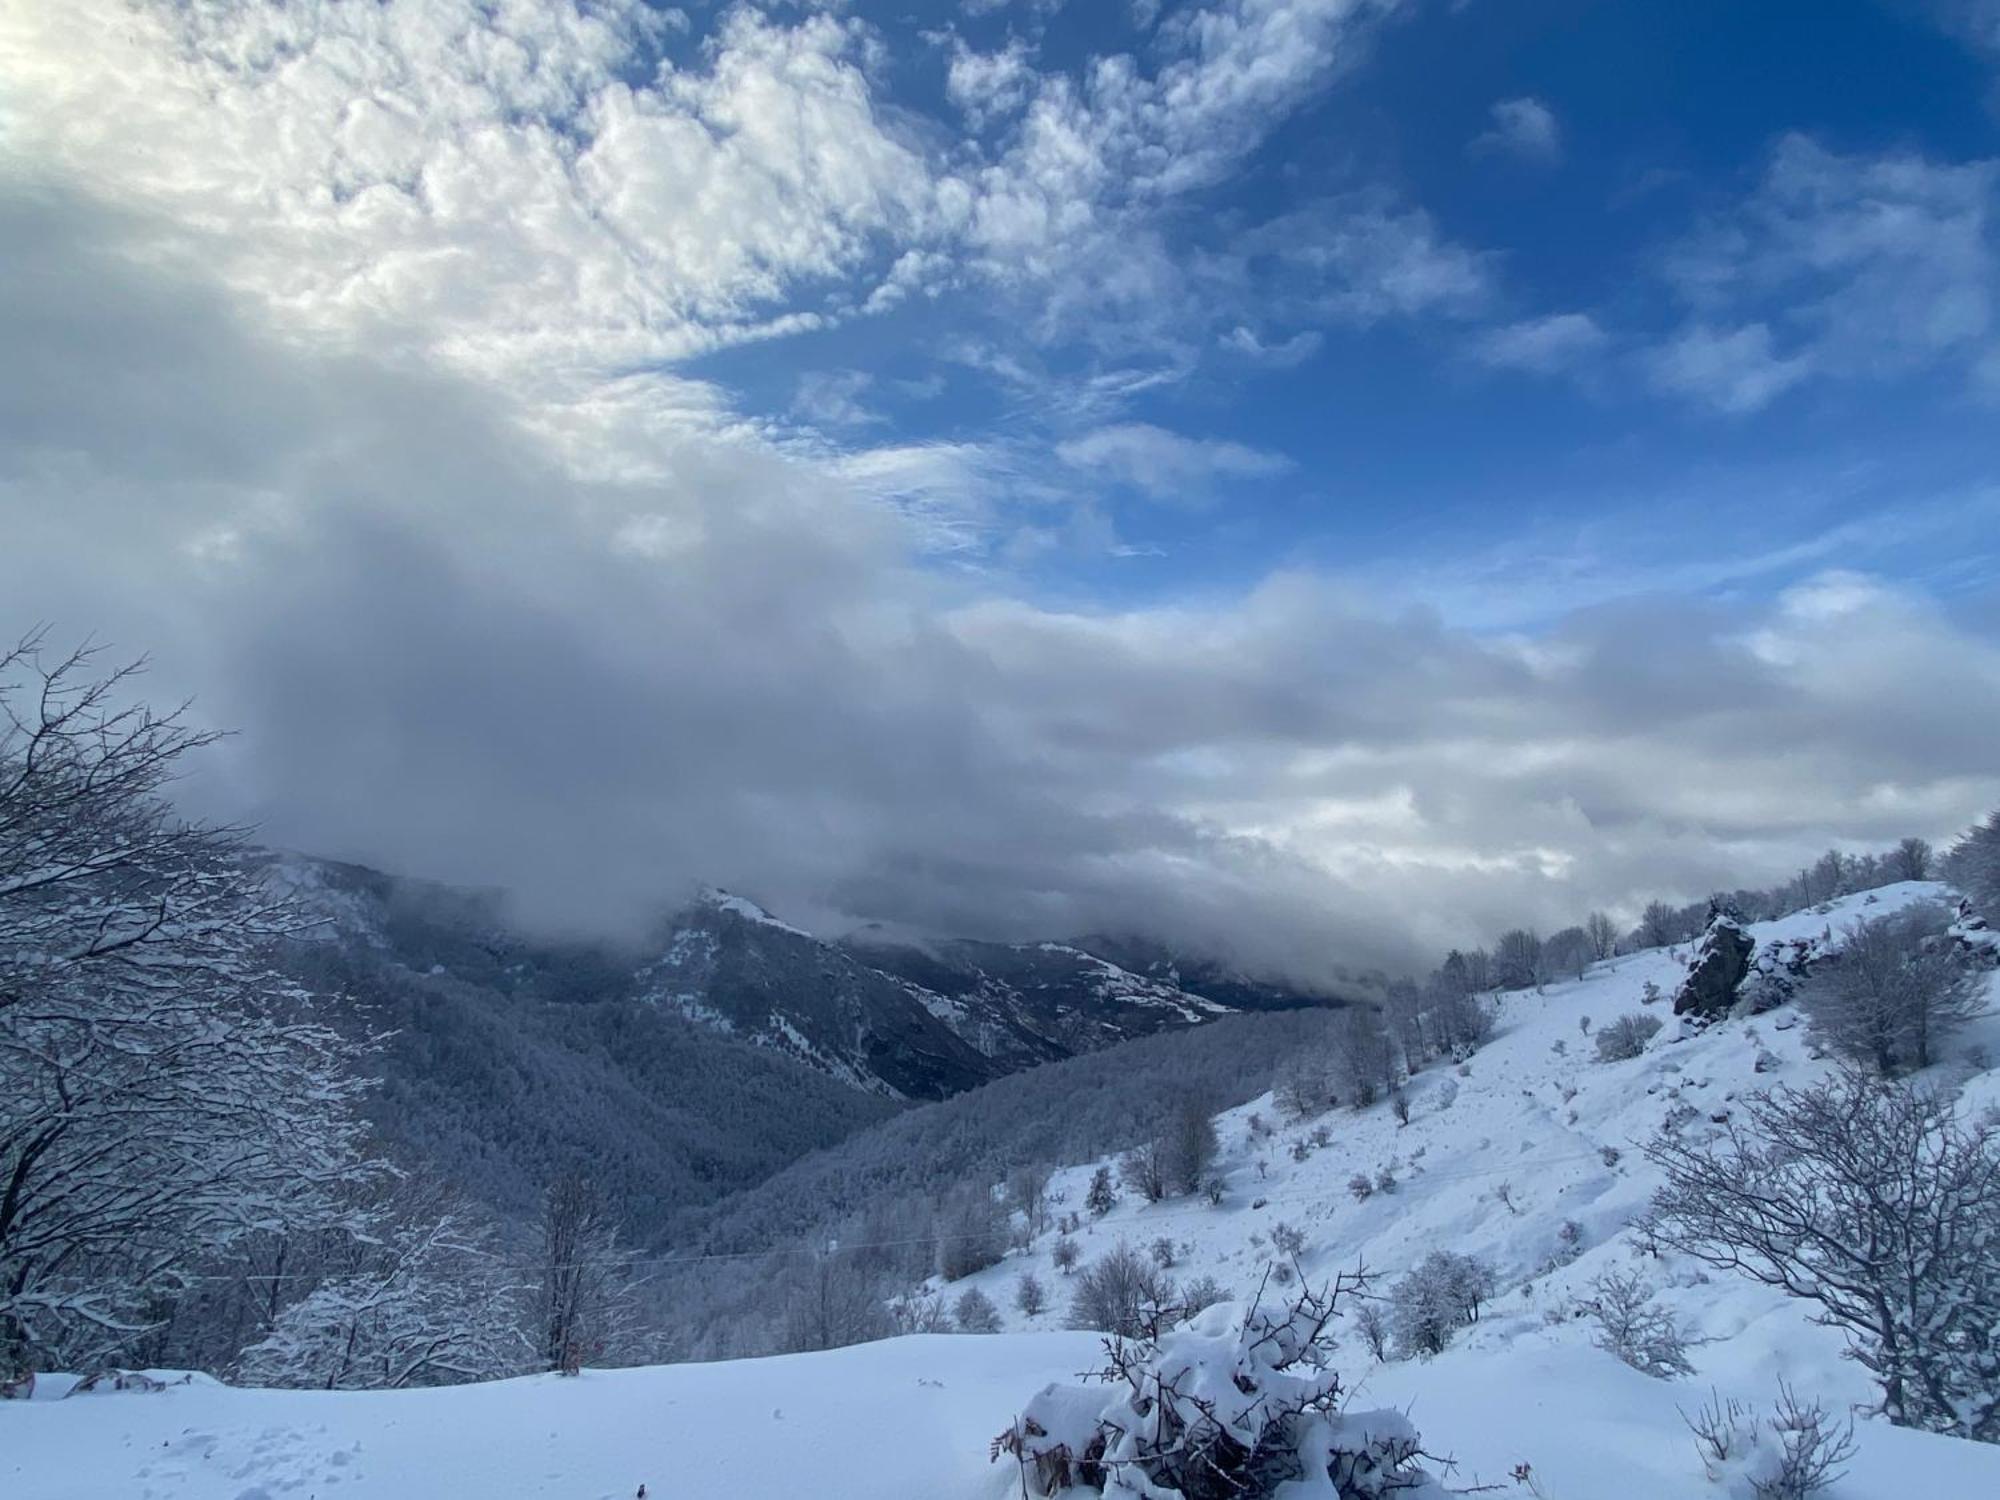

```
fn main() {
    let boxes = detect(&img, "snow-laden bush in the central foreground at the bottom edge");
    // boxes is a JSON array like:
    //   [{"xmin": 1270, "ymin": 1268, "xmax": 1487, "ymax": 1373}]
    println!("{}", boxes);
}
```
[{"xmin": 992, "ymin": 1278, "xmax": 1446, "ymax": 1500}]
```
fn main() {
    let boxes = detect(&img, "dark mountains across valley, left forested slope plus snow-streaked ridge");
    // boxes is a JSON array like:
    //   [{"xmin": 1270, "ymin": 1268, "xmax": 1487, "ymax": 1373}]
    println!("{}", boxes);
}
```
[{"xmin": 250, "ymin": 852, "xmax": 1344, "ymax": 1242}]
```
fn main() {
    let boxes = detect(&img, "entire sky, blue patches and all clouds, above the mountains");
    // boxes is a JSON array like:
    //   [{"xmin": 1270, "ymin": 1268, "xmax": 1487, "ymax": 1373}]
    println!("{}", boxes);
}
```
[{"xmin": 0, "ymin": 0, "xmax": 2000, "ymax": 978}]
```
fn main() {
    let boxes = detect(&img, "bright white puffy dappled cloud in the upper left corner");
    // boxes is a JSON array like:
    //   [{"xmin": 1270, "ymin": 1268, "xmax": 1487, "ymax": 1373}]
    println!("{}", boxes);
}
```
[{"xmin": 0, "ymin": 0, "xmax": 938, "ymax": 388}]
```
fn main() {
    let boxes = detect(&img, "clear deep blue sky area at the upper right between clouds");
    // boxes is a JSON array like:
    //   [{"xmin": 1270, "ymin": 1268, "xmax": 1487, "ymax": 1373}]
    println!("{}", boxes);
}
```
[{"xmin": 664, "ymin": 0, "xmax": 1994, "ymax": 610}]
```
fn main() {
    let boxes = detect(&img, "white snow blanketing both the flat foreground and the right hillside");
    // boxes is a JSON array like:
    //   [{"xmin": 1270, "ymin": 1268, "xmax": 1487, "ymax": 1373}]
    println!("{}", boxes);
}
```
[{"xmin": 0, "ymin": 884, "xmax": 2000, "ymax": 1500}]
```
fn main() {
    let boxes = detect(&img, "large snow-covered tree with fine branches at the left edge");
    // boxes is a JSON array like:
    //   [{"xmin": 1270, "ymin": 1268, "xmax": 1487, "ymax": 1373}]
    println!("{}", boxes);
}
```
[{"xmin": 0, "ymin": 640, "xmax": 374, "ymax": 1372}]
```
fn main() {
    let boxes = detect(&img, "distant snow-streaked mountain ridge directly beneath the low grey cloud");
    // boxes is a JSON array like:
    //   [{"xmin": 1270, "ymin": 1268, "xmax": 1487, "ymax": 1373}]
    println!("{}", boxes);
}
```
[{"xmin": 262, "ymin": 856, "xmax": 1334, "ymax": 1100}]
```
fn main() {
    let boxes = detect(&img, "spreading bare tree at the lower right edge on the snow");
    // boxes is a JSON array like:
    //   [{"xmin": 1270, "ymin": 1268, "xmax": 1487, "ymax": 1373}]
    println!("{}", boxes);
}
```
[{"xmin": 1646, "ymin": 1072, "xmax": 2000, "ymax": 1442}]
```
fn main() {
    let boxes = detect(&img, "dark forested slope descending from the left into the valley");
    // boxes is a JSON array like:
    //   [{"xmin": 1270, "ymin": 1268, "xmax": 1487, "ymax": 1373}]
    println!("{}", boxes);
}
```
[{"xmin": 260, "ymin": 856, "xmax": 896, "ymax": 1242}]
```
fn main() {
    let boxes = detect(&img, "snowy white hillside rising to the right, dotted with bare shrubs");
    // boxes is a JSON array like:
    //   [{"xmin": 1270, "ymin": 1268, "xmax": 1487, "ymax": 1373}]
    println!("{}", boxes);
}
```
[{"xmin": 924, "ymin": 882, "xmax": 2000, "ymax": 1500}]
